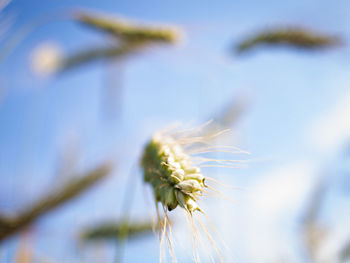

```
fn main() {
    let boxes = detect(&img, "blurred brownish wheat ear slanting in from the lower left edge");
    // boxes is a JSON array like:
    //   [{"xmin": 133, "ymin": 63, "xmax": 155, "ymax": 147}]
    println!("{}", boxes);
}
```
[{"xmin": 0, "ymin": 163, "xmax": 111, "ymax": 242}]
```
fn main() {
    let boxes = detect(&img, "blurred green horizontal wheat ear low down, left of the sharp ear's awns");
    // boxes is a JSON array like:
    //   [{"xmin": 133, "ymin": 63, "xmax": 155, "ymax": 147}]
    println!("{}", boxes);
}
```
[{"xmin": 82, "ymin": 220, "xmax": 154, "ymax": 241}]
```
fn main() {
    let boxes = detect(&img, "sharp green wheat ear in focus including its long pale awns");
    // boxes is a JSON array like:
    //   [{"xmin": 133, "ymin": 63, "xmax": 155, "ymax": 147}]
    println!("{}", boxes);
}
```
[{"xmin": 141, "ymin": 126, "xmax": 242, "ymax": 262}]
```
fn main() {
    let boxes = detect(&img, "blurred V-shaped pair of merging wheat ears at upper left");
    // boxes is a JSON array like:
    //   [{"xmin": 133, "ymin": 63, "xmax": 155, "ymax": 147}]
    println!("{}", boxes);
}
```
[{"xmin": 49, "ymin": 11, "xmax": 180, "ymax": 73}]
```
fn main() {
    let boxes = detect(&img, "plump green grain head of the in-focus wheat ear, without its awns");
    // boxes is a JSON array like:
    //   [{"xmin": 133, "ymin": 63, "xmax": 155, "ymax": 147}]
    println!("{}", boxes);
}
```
[{"xmin": 142, "ymin": 134, "xmax": 205, "ymax": 213}]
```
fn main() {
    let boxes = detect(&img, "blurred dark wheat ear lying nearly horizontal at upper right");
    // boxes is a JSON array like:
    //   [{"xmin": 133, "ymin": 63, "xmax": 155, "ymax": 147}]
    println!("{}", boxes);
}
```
[{"xmin": 234, "ymin": 27, "xmax": 343, "ymax": 54}]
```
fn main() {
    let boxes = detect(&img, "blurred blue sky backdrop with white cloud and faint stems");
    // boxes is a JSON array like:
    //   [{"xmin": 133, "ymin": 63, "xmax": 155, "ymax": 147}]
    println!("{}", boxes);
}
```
[{"xmin": 0, "ymin": 0, "xmax": 350, "ymax": 262}]
